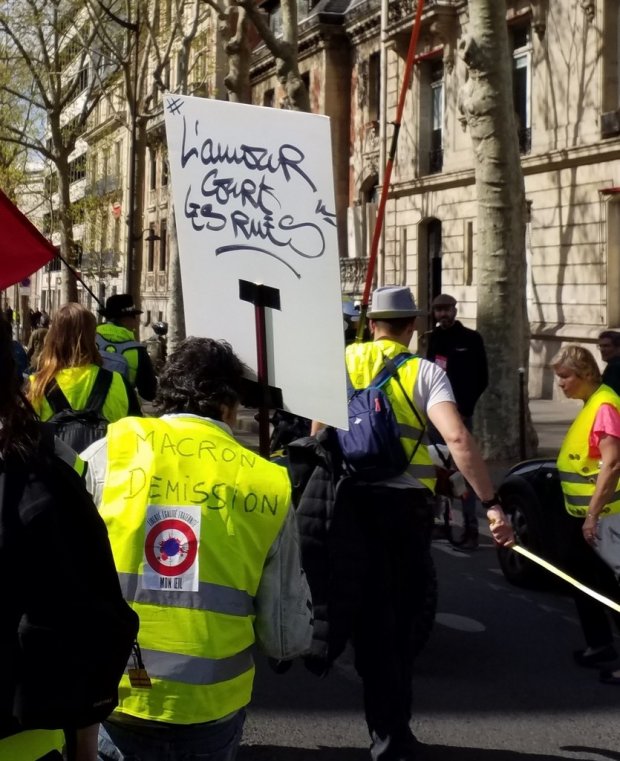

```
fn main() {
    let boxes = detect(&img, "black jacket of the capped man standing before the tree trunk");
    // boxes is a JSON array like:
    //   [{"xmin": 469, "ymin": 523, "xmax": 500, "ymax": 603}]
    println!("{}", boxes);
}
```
[{"xmin": 426, "ymin": 320, "xmax": 489, "ymax": 417}]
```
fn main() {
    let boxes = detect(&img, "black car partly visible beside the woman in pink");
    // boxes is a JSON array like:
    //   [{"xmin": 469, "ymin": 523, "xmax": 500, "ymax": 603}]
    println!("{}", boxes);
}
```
[{"xmin": 497, "ymin": 459, "xmax": 570, "ymax": 588}]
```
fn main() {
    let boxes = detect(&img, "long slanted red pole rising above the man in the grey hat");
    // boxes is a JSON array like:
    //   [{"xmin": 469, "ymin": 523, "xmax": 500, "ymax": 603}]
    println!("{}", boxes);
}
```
[{"xmin": 355, "ymin": 0, "xmax": 424, "ymax": 341}]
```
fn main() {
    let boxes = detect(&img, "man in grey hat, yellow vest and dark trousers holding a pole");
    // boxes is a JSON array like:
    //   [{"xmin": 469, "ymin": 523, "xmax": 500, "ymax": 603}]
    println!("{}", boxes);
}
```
[{"xmin": 314, "ymin": 286, "xmax": 514, "ymax": 761}]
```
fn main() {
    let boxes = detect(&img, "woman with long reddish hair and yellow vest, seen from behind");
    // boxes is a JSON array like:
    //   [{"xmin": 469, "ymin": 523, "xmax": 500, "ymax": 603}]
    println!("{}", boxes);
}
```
[{"xmin": 28, "ymin": 303, "xmax": 141, "ymax": 434}]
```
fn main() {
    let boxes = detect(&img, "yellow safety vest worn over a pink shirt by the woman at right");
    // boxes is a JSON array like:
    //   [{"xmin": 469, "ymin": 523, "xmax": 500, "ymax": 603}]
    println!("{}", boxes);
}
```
[{"xmin": 557, "ymin": 385, "xmax": 620, "ymax": 518}]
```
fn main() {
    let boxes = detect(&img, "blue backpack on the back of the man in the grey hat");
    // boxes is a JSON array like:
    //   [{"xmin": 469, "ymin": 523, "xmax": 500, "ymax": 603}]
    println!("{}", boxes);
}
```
[{"xmin": 337, "ymin": 352, "xmax": 415, "ymax": 482}]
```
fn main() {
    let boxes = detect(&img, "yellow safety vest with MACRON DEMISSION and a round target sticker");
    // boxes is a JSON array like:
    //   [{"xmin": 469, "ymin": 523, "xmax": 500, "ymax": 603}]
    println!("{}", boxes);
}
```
[{"xmin": 100, "ymin": 416, "xmax": 291, "ymax": 724}]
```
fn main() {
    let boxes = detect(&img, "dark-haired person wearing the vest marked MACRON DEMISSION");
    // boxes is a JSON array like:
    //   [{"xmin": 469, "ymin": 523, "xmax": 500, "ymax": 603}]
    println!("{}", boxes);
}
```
[{"xmin": 82, "ymin": 338, "xmax": 312, "ymax": 761}]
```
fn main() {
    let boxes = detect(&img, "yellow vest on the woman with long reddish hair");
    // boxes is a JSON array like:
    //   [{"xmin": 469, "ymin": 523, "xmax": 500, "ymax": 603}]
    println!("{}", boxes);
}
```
[{"xmin": 31, "ymin": 365, "xmax": 129, "ymax": 423}]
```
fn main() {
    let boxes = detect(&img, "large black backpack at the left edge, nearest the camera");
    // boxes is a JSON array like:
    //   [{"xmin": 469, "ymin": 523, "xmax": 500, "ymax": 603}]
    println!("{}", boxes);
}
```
[{"xmin": 0, "ymin": 424, "xmax": 138, "ymax": 730}]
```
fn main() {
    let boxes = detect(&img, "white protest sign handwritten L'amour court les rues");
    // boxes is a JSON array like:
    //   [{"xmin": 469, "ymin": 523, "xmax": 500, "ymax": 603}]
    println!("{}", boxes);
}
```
[{"xmin": 164, "ymin": 95, "xmax": 347, "ymax": 428}]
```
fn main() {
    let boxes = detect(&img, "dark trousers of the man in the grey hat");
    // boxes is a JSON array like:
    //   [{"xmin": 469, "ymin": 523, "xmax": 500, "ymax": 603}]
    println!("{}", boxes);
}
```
[{"xmin": 330, "ymin": 485, "xmax": 432, "ymax": 761}]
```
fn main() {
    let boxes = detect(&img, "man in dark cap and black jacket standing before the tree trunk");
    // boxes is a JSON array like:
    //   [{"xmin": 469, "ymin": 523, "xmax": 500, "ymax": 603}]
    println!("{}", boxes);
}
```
[{"xmin": 426, "ymin": 293, "xmax": 489, "ymax": 550}]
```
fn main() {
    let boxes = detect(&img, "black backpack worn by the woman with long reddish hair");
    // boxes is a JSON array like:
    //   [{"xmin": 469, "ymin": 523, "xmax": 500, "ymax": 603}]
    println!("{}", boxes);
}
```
[{"xmin": 45, "ymin": 368, "xmax": 112, "ymax": 452}]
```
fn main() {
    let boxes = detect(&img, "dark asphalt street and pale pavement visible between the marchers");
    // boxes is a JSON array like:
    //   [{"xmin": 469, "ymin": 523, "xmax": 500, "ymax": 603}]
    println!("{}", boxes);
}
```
[{"xmin": 231, "ymin": 400, "xmax": 620, "ymax": 761}]
